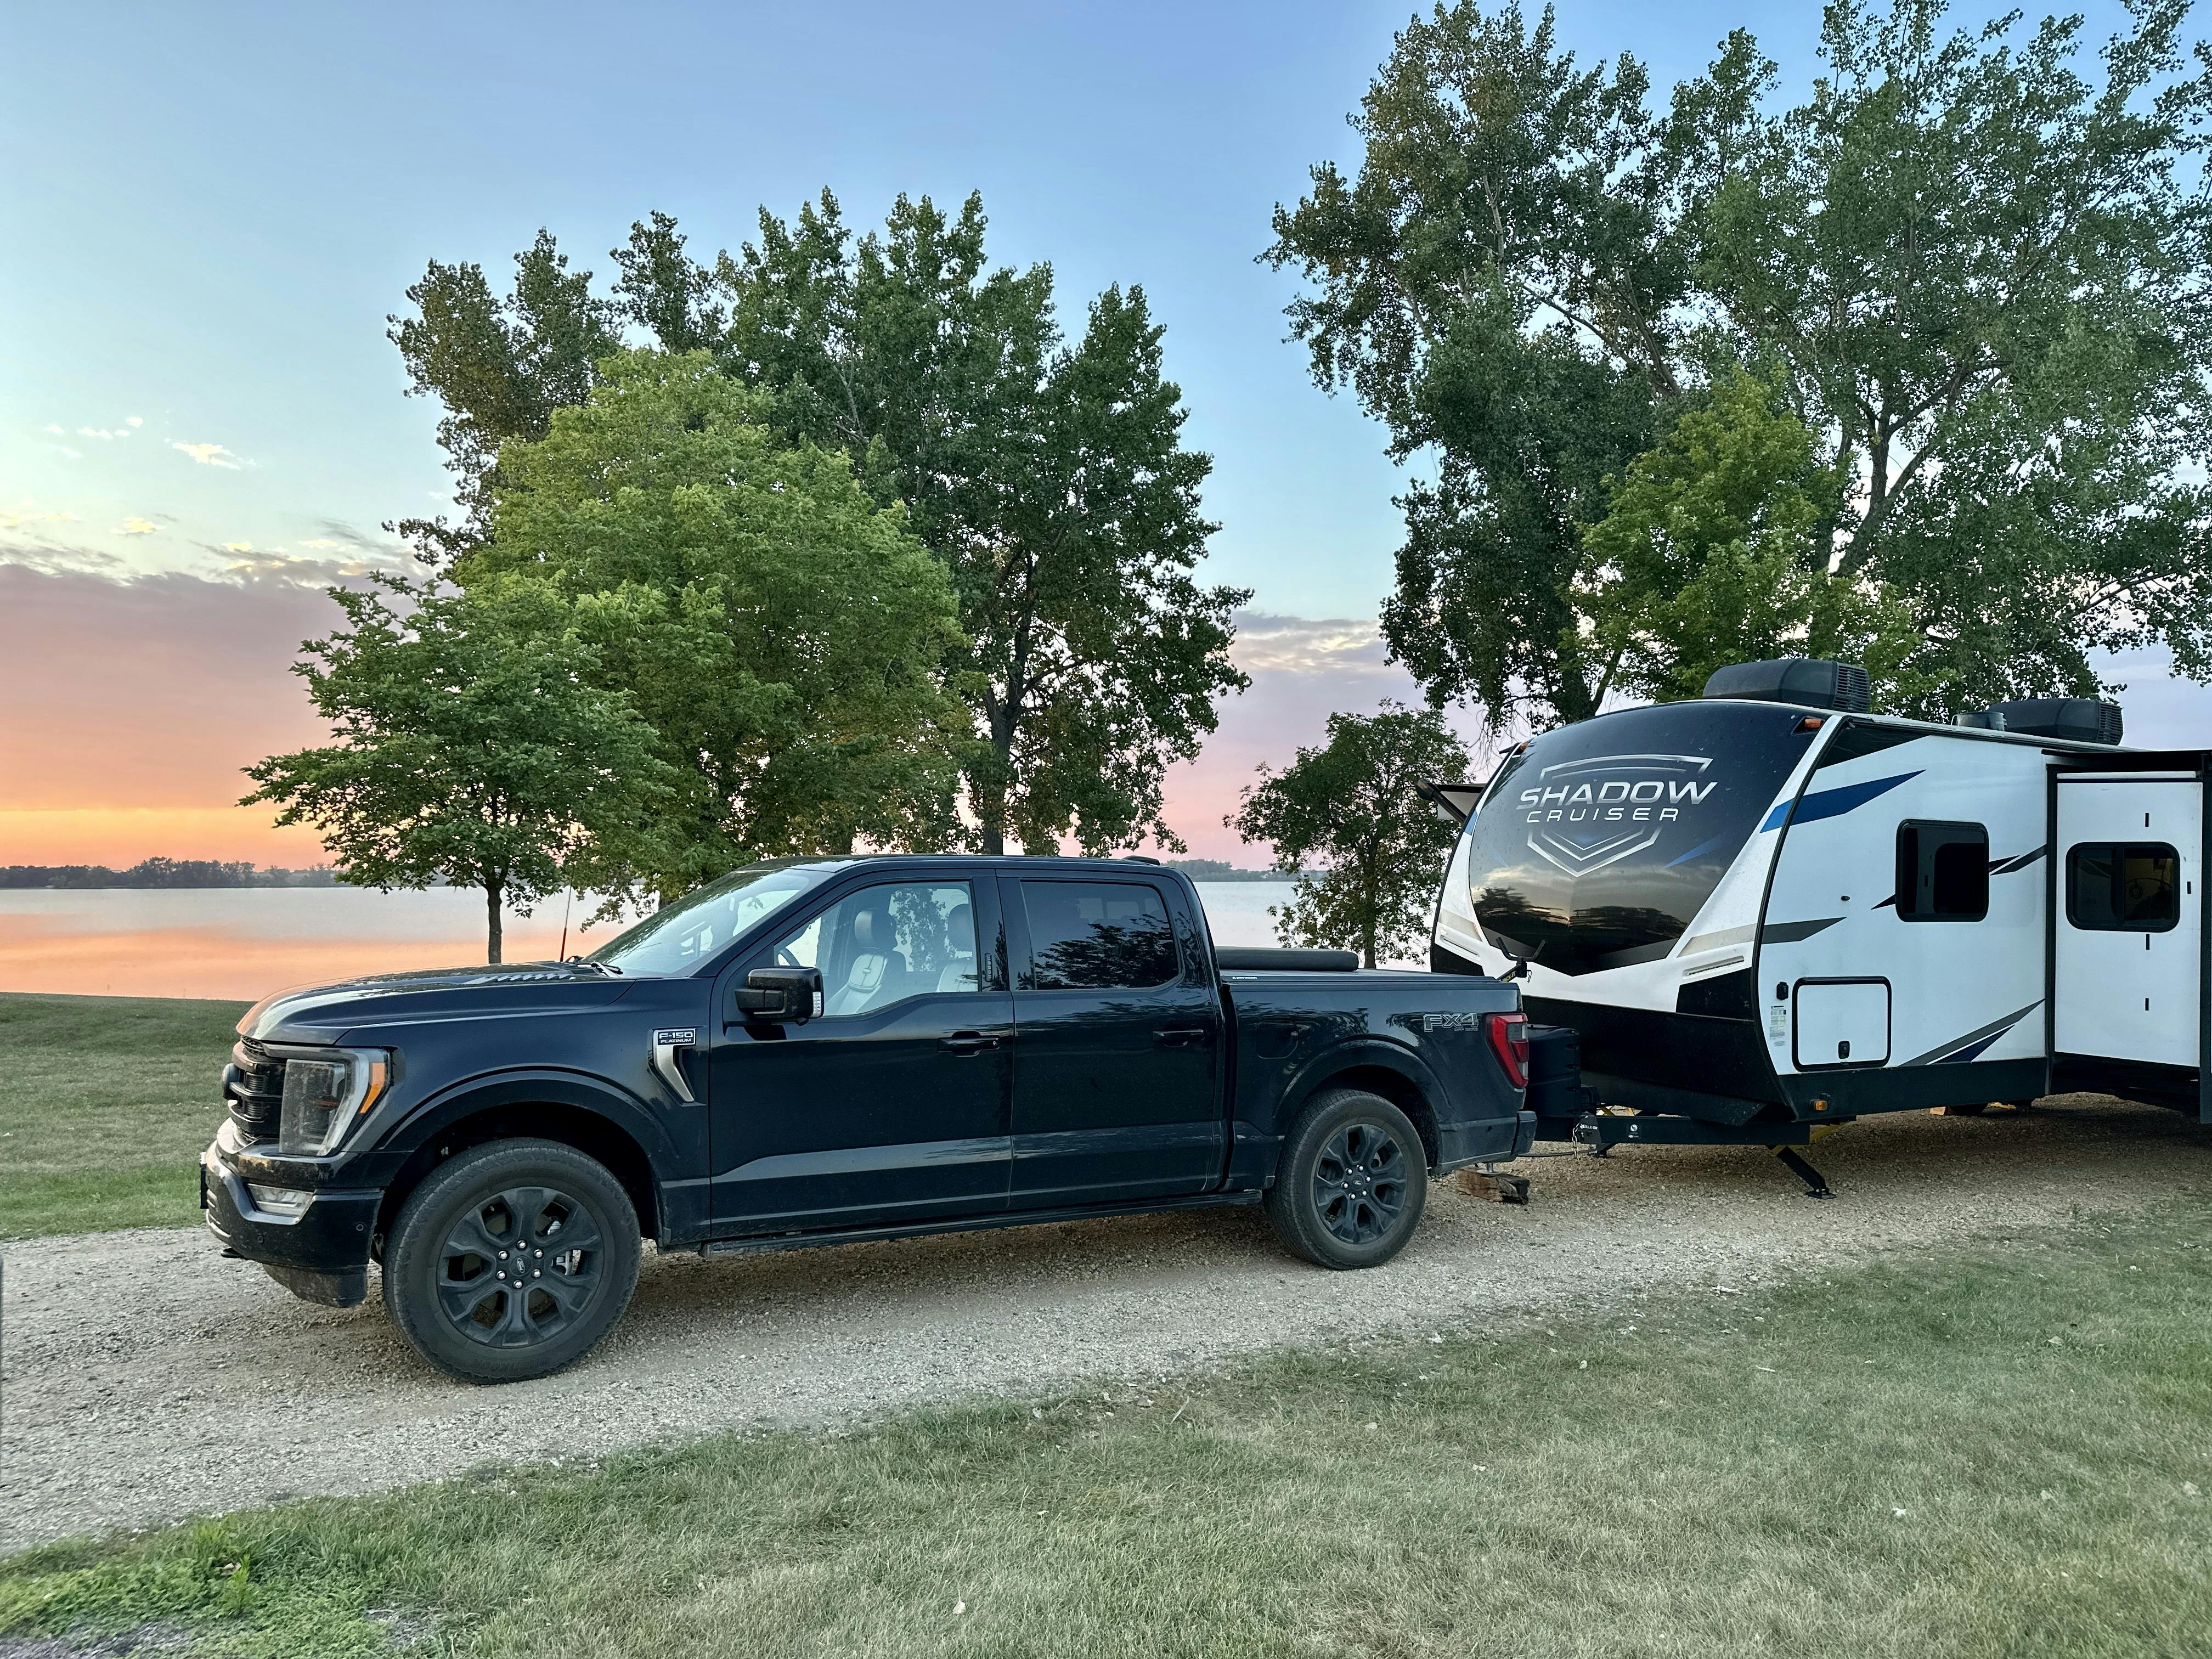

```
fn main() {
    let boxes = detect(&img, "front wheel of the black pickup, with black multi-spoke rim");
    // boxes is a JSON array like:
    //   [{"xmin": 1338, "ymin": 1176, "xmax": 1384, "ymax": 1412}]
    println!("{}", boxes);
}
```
[{"xmin": 385, "ymin": 1142, "xmax": 639, "ymax": 1383}]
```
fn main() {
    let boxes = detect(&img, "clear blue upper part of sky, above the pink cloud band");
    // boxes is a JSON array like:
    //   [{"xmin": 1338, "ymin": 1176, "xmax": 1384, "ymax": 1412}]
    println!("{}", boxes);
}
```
[{"xmin": 0, "ymin": 0, "xmax": 1840, "ymax": 617}]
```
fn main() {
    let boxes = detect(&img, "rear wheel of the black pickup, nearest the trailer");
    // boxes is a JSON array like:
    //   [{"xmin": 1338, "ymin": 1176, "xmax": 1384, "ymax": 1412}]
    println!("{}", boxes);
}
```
[{"xmin": 1267, "ymin": 1088, "xmax": 1429, "ymax": 1267}]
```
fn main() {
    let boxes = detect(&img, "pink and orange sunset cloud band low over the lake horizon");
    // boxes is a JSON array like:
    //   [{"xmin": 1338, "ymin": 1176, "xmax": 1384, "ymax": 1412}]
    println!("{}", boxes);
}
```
[{"xmin": 0, "ymin": 579, "xmax": 1504, "ymax": 865}]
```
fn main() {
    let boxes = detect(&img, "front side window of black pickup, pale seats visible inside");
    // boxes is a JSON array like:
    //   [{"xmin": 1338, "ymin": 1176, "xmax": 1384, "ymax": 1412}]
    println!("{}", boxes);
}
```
[{"xmin": 774, "ymin": 881, "xmax": 975, "ymax": 1018}]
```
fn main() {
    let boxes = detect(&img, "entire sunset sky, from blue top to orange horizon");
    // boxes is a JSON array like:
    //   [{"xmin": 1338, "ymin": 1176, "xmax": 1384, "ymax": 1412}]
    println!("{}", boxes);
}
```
[{"xmin": 0, "ymin": 0, "xmax": 2185, "ymax": 865}]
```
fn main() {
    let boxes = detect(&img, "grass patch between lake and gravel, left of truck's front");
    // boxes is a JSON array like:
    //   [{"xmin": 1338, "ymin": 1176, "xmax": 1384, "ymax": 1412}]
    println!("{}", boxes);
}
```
[{"xmin": 0, "ymin": 995, "xmax": 246, "ymax": 1239}]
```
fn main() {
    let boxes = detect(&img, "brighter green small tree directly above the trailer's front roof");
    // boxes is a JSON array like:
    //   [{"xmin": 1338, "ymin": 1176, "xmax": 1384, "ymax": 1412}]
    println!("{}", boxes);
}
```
[{"xmin": 1575, "ymin": 371, "xmax": 1916, "ymax": 701}]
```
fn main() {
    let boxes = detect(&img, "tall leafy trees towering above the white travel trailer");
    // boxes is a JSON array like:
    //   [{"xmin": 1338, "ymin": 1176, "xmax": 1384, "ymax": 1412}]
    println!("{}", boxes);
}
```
[{"xmin": 1267, "ymin": 0, "xmax": 2212, "ymax": 723}]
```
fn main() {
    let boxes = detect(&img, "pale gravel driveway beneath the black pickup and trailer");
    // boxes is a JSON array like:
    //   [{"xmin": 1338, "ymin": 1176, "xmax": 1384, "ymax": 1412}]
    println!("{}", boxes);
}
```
[{"xmin": 0, "ymin": 1099, "xmax": 2212, "ymax": 1548}]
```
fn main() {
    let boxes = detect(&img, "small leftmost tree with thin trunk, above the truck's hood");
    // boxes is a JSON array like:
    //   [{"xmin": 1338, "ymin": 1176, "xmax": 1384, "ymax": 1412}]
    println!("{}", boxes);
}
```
[{"xmin": 241, "ymin": 577, "xmax": 673, "ymax": 962}]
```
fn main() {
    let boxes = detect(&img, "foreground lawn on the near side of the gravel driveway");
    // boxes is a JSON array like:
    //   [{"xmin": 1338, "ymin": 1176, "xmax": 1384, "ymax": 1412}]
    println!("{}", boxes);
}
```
[{"xmin": 0, "ymin": 1201, "xmax": 2212, "ymax": 1659}]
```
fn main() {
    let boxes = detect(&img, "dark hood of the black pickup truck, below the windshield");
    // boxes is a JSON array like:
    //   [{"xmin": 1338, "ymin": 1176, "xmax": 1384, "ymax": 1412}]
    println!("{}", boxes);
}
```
[{"xmin": 239, "ymin": 962, "xmax": 635, "ymax": 1042}]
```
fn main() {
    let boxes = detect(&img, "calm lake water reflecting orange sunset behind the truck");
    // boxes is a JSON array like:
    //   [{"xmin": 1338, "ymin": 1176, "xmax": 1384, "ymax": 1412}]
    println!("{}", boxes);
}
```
[{"xmin": 0, "ymin": 881, "xmax": 1290, "ymax": 1002}]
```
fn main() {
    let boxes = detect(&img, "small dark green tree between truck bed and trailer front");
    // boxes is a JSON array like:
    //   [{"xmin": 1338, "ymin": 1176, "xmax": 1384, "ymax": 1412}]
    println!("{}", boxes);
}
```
[{"xmin": 1226, "ymin": 701, "xmax": 1471, "ymax": 967}]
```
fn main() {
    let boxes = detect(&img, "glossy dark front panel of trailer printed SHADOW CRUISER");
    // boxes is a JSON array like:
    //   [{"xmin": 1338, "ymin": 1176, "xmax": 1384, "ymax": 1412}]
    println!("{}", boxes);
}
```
[{"xmin": 1466, "ymin": 699, "xmax": 1812, "ymax": 973}]
